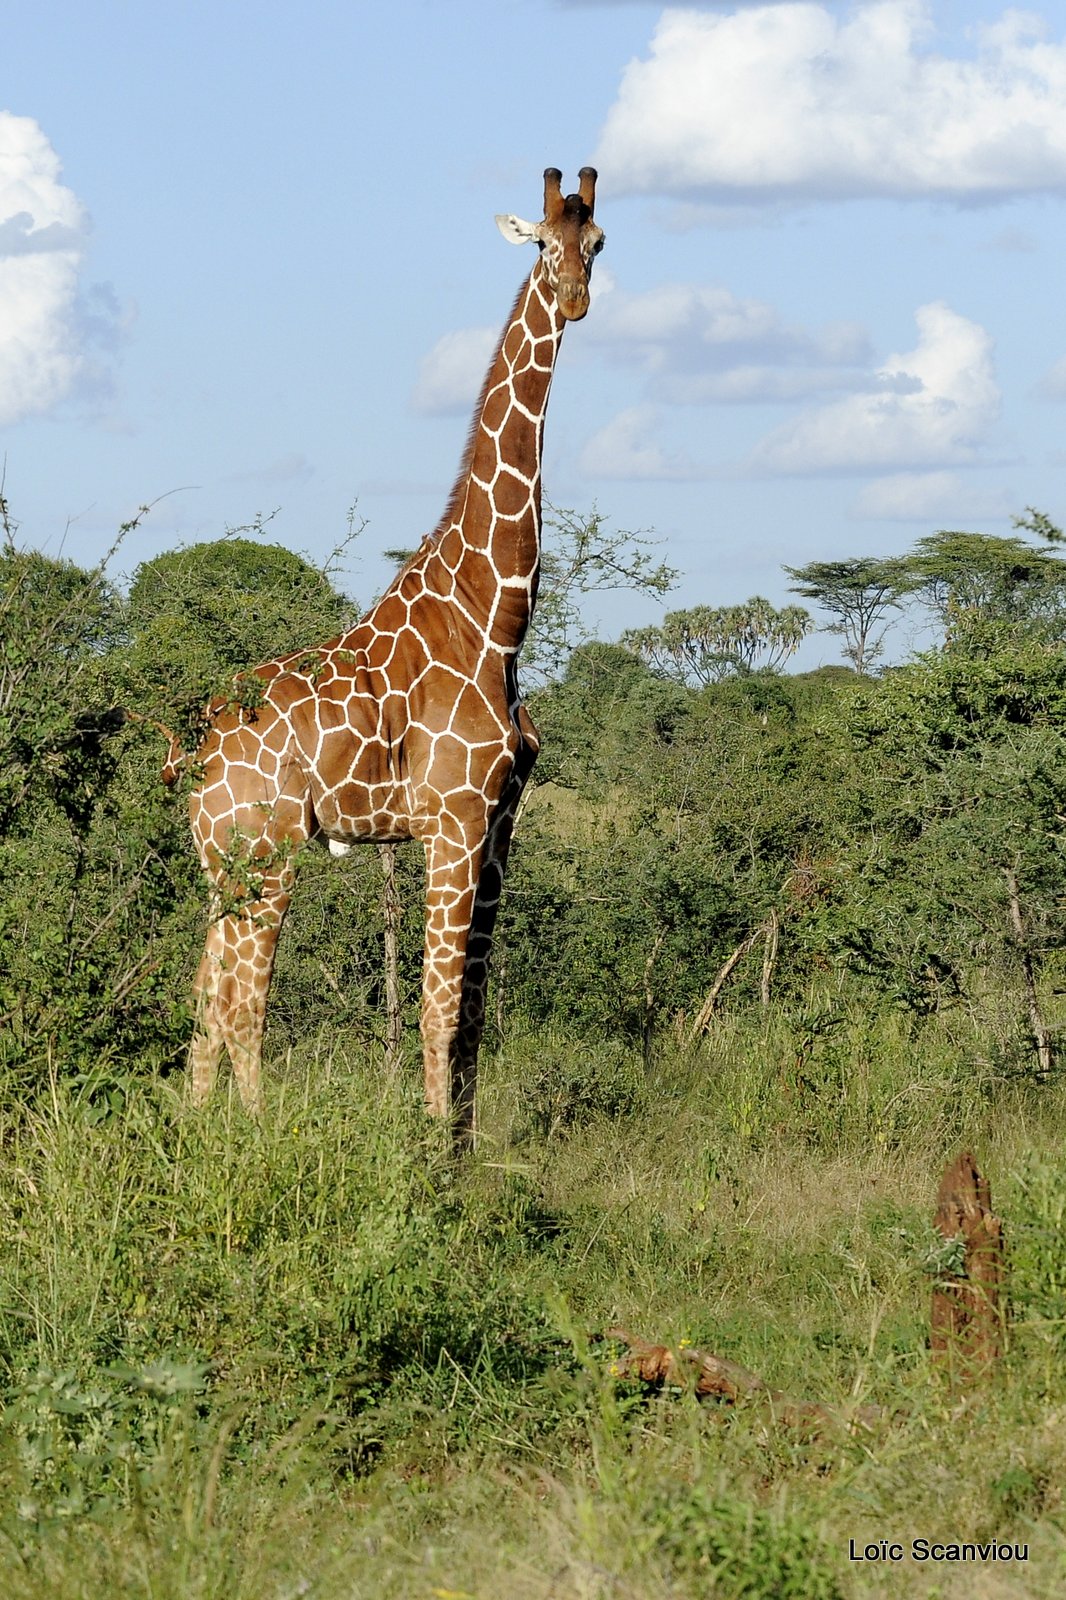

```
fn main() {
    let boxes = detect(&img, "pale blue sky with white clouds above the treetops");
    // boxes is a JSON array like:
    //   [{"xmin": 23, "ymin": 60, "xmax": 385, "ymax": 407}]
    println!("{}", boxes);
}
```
[{"xmin": 0, "ymin": 0, "xmax": 1066, "ymax": 661}]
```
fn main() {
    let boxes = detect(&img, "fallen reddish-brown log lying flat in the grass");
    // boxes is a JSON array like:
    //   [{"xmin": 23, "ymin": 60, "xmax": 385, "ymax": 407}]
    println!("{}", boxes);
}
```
[{"xmin": 603, "ymin": 1328, "xmax": 887, "ymax": 1435}]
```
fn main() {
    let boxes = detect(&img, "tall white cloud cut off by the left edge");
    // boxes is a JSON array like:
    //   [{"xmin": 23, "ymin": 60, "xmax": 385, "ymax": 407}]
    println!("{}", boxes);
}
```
[{"xmin": 0, "ymin": 110, "xmax": 88, "ymax": 426}]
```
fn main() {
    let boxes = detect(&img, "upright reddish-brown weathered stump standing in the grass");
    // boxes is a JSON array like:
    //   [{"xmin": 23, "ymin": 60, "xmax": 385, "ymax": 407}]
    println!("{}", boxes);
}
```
[{"xmin": 930, "ymin": 1150, "xmax": 1004, "ymax": 1382}]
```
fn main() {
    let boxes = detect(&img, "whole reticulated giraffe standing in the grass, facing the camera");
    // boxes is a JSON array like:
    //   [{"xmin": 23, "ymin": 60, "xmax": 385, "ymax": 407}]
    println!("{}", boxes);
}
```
[{"xmin": 178, "ymin": 166, "xmax": 603, "ymax": 1147}]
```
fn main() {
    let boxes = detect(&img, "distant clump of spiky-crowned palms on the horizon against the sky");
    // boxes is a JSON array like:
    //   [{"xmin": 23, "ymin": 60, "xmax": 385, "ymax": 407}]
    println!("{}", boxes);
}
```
[{"xmin": 621, "ymin": 595, "xmax": 815, "ymax": 686}]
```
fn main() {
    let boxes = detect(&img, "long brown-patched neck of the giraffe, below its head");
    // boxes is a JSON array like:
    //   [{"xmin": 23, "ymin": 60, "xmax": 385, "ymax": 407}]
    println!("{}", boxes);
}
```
[{"xmin": 434, "ymin": 261, "xmax": 565, "ymax": 654}]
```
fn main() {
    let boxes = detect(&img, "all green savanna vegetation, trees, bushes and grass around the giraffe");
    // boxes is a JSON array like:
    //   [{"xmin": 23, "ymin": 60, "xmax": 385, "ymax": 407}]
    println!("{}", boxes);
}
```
[{"xmin": 0, "ymin": 492, "xmax": 1066, "ymax": 1600}]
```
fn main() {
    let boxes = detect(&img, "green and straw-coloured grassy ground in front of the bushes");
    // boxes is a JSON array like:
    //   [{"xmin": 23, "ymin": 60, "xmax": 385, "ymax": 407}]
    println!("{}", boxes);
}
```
[{"xmin": 0, "ymin": 1013, "xmax": 1066, "ymax": 1600}]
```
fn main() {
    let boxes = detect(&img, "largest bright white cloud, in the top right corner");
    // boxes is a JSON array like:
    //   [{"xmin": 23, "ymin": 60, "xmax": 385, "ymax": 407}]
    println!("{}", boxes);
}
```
[{"xmin": 595, "ymin": 0, "xmax": 1066, "ymax": 200}]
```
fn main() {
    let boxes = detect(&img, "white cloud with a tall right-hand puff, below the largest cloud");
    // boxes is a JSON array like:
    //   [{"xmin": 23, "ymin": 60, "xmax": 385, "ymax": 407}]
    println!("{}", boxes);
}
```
[{"xmin": 749, "ymin": 301, "xmax": 1000, "ymax": 475}]
